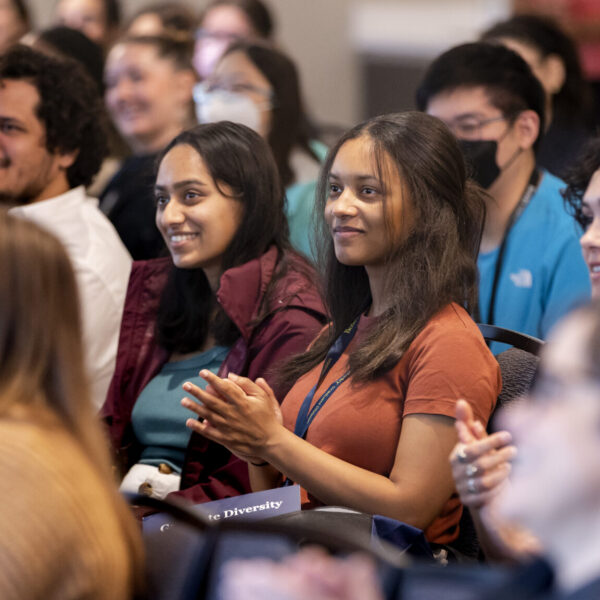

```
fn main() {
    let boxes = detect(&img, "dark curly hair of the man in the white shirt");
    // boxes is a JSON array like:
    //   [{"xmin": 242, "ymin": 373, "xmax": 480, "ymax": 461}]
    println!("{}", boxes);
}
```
[{"xmin": 0, "ymin": 44, "xmax": 108, "ymax": 188}]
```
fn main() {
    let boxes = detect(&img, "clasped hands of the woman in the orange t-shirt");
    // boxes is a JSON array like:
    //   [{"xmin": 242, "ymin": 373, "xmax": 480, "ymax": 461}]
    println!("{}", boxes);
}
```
[{"xmin": 181, "ymin": 370, "xmax": 283, "ymax": 463}]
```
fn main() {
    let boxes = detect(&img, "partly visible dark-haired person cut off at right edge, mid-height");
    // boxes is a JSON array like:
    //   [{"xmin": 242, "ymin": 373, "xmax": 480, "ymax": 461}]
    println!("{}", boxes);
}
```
[{"xmin": 563, "ymin": 136, "xmax": 600, "ymax": 298}]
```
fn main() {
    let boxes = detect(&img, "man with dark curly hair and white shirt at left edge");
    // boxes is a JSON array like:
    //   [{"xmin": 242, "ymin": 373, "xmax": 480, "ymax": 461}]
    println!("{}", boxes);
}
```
[{"xmin": 0, "ymin": 46, "xmax": 131, "ymax": 407}]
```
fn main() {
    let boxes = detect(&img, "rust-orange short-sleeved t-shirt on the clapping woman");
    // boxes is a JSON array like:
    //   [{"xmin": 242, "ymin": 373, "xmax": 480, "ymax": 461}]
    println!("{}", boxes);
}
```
[{"xmin": 281, "ymin": 304, "xmax": 502, "ymax": 544}]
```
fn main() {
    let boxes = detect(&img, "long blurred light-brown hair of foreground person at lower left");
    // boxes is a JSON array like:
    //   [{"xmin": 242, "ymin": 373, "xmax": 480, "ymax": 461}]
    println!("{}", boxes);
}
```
[{"xmin": 0, "ymin": 210, "xmax": 142, "ymax": 591}]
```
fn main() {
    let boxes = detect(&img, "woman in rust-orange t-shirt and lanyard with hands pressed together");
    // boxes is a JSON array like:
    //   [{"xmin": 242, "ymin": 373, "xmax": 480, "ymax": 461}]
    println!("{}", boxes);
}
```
[{"xmin": 182, "ymin": 112, "xmax": 501, "ymax": 543}]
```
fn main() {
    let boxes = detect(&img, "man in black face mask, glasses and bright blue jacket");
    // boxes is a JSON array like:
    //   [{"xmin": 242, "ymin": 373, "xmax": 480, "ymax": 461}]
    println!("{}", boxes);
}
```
[{"xmin": 417, "ymin": 43, "xmax": 590, "ymax": 352}]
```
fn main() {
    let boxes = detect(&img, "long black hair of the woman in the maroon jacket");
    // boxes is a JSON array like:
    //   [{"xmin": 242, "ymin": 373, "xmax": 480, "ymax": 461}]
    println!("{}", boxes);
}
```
[{"xmin": 156, "ymin": 121, "xmax": 296, "ymax": 353}]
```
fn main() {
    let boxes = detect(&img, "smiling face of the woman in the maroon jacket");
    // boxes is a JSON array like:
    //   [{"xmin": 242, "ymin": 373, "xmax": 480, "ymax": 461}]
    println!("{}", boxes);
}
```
[{"xmin": 155, "ymin": 144, "xmax": 244, "ymax": 289}]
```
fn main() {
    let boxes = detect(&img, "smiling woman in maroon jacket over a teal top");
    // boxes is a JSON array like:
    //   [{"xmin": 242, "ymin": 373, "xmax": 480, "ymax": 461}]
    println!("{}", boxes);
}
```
[{"xmin": 103, "ymin": 122, "xmax": 324, "ymax": 503}]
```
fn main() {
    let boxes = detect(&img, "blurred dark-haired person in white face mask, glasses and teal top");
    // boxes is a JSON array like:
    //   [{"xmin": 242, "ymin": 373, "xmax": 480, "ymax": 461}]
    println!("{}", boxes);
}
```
[{"xmin": 194, "ymin": 42, "xmax": 327, "ymax": 257}]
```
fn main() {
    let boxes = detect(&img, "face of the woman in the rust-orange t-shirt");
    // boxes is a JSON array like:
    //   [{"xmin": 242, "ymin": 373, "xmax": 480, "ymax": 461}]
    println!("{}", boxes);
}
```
[{"xmin": 325, "ymin": 135, "xmax": 405, "ymax": 268}]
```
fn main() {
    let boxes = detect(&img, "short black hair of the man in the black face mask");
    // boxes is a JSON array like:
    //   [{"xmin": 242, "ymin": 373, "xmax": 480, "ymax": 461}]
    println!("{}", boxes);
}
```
[{"xmin": 416, "ymin": 42, "xmax": 546, "ymax": 148}]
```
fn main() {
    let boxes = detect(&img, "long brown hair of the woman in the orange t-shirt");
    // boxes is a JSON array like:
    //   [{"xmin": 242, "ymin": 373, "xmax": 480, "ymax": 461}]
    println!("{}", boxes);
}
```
[{"xmin": 286, "ymin": 112, "xmax": 485, "ymax": 381}]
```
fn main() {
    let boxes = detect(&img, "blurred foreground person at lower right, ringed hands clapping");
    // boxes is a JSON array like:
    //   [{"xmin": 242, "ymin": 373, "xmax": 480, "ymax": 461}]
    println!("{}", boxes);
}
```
[{"xmin": 451, "ymin": 300, "xmax": 600, "ymax": 600}]
